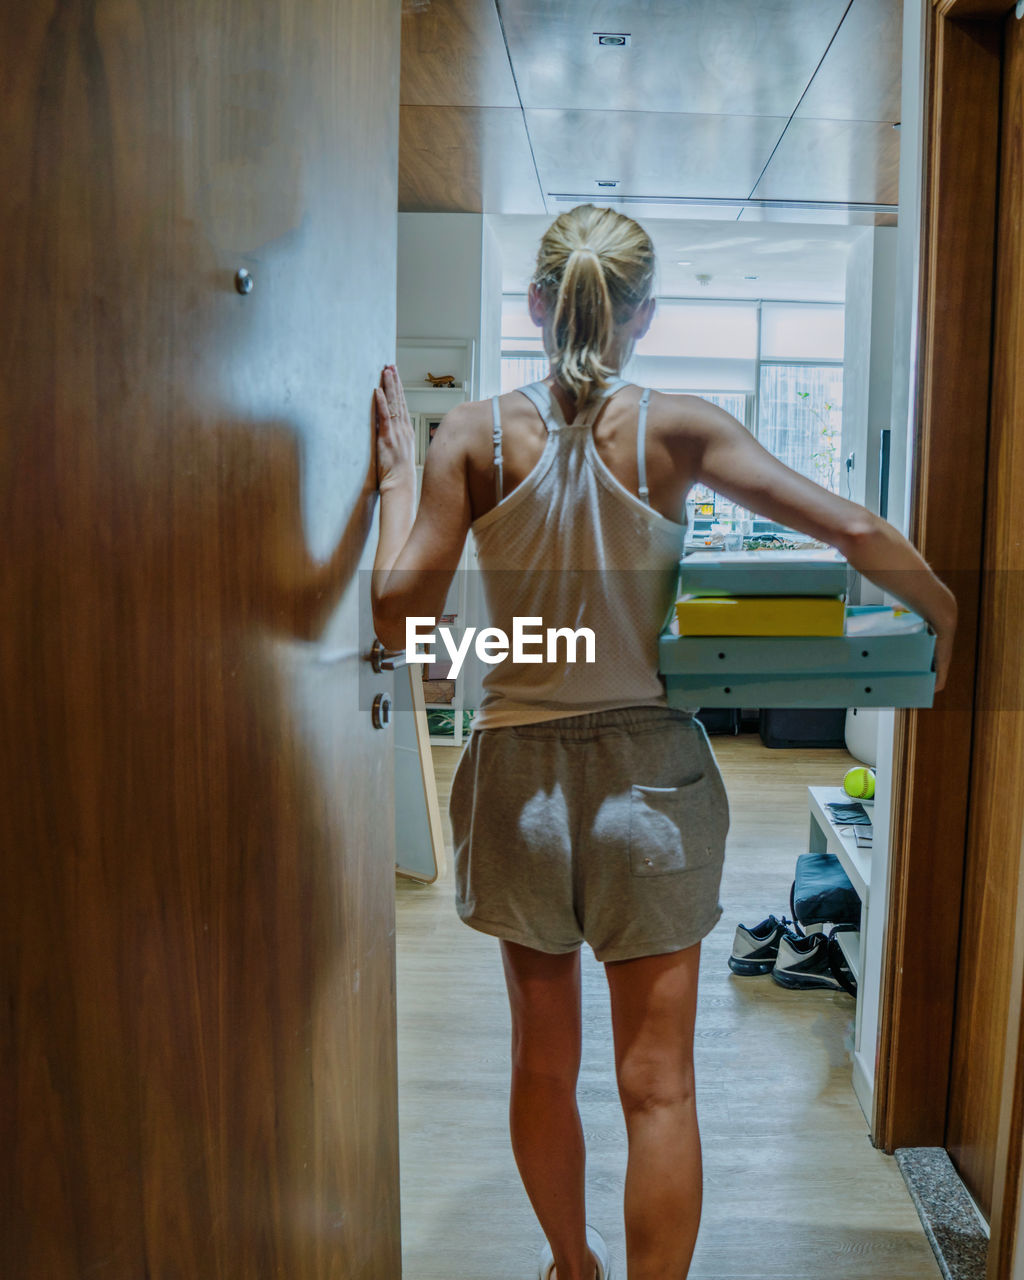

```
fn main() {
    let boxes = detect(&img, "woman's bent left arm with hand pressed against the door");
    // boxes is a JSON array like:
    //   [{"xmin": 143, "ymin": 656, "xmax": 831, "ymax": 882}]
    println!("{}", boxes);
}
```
[{"xmin": 371, "ymin": 366, "xmax": 470, "ymax": 649}]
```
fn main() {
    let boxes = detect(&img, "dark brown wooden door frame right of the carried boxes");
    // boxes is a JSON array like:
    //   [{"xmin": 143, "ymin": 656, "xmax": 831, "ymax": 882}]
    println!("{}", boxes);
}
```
[{"xmin": 872, "ymin": 0, "xmax": 1024, "ymax": 1280}]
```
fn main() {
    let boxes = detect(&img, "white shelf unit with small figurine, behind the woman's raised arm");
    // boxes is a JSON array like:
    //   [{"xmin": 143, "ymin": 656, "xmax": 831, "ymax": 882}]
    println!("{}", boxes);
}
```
[{"xmin": 397, "ymin": 338, "xmax": 476, "ymax": 746}]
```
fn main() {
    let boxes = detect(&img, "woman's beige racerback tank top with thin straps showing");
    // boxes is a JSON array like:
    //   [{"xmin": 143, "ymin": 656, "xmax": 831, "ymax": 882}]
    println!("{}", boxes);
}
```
[{"xmin": 471, "ymin": 379, "xmax": 686, "ymax": 728}]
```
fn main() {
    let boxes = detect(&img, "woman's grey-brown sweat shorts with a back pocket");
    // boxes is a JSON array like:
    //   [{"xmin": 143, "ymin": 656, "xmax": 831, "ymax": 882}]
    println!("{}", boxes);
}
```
[{"xmin": 448, "ymin": 707, "xmax": 728, "ymax": 960}]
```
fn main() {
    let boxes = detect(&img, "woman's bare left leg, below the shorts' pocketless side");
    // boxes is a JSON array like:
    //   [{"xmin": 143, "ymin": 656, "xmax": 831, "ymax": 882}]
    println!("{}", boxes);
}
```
[{"xmin": 502, "ymin": 941, "xmax": 596, "ymax": 1280}]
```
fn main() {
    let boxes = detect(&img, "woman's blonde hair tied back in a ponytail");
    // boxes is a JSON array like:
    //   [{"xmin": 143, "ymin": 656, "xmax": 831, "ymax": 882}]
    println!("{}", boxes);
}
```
[{"xmin": 534, "ymin": 205, "xmax": 654, "ymax": 411}]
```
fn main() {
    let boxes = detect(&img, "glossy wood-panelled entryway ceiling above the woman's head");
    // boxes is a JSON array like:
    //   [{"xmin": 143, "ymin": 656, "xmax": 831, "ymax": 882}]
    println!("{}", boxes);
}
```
[{"xmin": 399, "ymin": 0, "xmax": 902, "ymax": 229}]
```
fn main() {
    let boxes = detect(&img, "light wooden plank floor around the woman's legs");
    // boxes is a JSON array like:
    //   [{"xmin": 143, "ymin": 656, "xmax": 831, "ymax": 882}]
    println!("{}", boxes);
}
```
[{"xmin": 398, "ymin": 733, "xmax": 940, "ymax": 1280}]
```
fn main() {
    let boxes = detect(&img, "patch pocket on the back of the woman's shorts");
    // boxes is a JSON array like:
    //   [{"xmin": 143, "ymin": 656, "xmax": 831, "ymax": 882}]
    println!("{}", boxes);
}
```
[{"xmin": 630, "ymin": 774, "xmax": 723, "ymax": 876}]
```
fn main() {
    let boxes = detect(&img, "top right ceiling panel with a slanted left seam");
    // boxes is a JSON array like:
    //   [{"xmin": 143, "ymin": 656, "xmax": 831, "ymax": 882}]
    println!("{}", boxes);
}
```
[{"xmin": 796, "ymin": 0, "xmax": 904, "ymax": 122}]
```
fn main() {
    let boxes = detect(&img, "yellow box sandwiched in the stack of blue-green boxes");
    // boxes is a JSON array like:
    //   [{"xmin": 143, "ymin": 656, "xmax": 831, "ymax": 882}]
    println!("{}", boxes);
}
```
[{"xmin": 676, "ymin": 595, "xmax": 846, "ymax": 636}]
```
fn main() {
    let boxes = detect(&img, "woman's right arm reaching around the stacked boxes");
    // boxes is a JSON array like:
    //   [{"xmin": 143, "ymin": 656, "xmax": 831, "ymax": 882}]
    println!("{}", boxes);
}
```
[{"xmin": 680, "ymin": 397, "xmax": 956, "ymax": 691}]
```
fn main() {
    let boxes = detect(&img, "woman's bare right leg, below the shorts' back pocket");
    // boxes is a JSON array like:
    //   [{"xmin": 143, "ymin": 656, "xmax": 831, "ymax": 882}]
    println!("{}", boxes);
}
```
[{"xmin": 604, "ymin": 942, "xmax": 703, "ymax": 1280}]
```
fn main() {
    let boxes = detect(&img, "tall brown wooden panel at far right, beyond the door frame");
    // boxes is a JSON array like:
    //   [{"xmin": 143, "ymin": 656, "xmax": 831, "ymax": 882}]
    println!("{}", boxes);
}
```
[{"xmin": 947, "ymin": 0, "xmax": 1024, "ymax": 1216}]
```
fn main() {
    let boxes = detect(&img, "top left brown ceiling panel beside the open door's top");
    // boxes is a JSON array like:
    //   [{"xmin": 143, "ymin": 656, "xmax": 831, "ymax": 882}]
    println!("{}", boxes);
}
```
[{"xmin": 402, "ymin": 0, "xmax": 520, "ymax": 108}]
